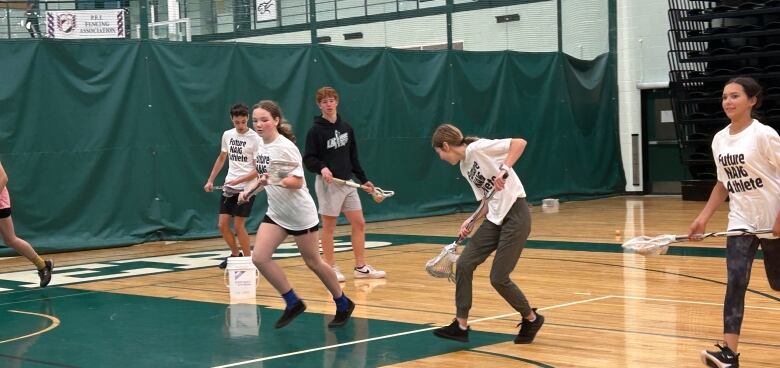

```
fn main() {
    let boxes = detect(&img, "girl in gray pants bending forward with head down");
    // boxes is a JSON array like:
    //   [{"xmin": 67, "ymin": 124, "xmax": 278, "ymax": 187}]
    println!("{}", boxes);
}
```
[{"xmin": 431, "ymin": 124, "xmax": 544, "ymax": 344}]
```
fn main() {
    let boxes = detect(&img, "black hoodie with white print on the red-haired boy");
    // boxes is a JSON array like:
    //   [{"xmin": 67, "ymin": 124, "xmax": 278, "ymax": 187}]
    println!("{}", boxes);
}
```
[{"xmin": 303, "ymin": 114, "xmax": 368, "ymax": 184}]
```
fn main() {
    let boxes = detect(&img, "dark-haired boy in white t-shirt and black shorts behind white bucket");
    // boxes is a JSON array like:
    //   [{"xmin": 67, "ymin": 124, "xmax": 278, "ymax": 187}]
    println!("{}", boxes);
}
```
[{"xmin": 203, "ymin": 103, "xmax": 260, "ymax": 269}]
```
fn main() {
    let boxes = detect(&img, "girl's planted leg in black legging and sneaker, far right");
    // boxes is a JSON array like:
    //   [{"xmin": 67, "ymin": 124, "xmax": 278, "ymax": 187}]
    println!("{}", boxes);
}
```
[{"xmin": 701, "ymin": 235, "xmax": 759, "ymax": 367}]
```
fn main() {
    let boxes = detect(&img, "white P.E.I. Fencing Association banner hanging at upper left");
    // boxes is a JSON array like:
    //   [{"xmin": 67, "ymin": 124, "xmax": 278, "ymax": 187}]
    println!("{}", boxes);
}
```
[{"xmin": 46, "ymin": 9, "xmax": 125, "ymax": 39}]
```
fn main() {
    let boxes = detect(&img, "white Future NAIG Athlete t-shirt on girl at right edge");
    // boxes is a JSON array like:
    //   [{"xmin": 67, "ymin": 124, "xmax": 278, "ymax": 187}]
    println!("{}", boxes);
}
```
[{"xmin": 712, "ymin": 120, "xmax": 780, "ymax": 231}]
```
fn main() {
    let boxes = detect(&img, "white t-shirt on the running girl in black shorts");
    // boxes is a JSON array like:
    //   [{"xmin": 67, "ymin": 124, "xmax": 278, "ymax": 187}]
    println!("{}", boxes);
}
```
[{"xmin": 255, "ymin": 135, "xmax": 319, "ymax": 230}]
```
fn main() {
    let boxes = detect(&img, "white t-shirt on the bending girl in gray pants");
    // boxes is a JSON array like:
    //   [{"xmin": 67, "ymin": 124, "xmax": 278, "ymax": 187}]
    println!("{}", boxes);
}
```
[{"xmin": 460, "ymin": 138, "xmax": 525, "ymax": 225}]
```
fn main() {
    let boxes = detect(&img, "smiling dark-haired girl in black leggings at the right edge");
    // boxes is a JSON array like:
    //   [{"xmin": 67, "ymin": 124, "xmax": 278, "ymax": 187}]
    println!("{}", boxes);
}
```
[{"xmin": 688, "ymin": 77, "xmax": 780, "ymax": 367}]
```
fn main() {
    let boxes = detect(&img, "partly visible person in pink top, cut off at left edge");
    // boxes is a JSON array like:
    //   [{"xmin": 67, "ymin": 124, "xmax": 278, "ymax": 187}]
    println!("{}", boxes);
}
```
[{"xmin": 0, "ymin": 163, "xmax": 54, "ymax": 287}]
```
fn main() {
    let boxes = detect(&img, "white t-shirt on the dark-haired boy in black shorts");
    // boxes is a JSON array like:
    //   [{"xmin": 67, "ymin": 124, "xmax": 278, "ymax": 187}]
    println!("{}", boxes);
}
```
[{"xmin": 221, "ymin": 128, "xmax": 262, "ymax": 190}]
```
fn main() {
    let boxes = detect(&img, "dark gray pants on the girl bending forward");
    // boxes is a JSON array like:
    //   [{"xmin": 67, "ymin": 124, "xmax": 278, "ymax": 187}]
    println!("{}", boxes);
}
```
[{"xmin": 455, "ymin": 198, "xmax": 531, "ymax": 318}]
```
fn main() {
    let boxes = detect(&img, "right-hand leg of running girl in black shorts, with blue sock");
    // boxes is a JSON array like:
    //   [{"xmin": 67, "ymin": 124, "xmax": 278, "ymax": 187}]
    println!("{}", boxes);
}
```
[{"xmin": 295, "ymin": 230, "xmax": 355, "ymax": 327}]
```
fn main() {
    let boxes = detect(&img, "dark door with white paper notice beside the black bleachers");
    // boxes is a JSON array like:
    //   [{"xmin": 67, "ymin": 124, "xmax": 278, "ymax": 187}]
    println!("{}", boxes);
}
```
[{"xmin": 642, "ymin": 88, "xmax": 691, "ymax": 194}]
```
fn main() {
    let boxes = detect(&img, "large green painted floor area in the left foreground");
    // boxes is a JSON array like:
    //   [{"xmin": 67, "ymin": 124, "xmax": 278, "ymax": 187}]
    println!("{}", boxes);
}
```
[{"xmin": 0, "ymin": 288, "xmax": 513, "ymax": 368}]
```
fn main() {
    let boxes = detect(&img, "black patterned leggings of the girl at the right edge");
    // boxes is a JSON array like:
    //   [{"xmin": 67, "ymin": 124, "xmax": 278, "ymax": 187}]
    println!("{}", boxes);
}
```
[{"xmin": 723, "ymin": 235, "xmax": 780, "ymax": 335}]
